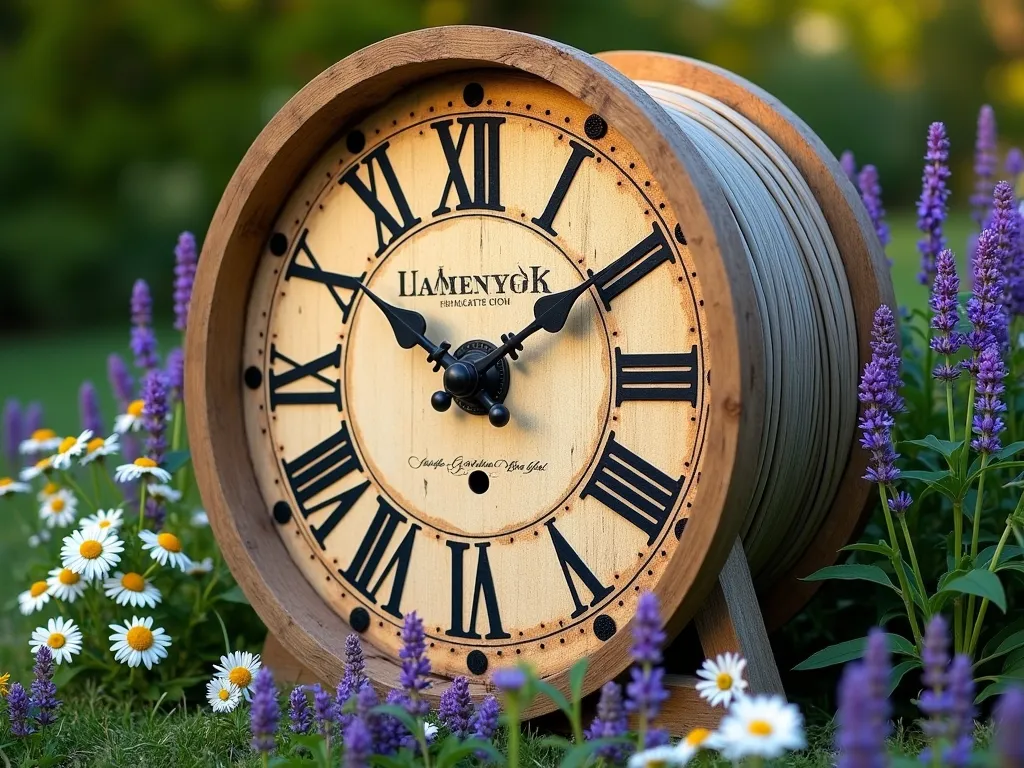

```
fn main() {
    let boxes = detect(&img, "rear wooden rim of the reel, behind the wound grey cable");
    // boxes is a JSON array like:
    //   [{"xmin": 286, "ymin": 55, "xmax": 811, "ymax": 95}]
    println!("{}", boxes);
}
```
[{"xmin": 595, "ymin": 51, "xmax": 896, "ymax": 631}]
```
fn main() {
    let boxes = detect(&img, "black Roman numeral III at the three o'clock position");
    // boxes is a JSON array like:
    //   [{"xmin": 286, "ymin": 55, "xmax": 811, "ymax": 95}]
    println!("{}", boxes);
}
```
[{"xmin": 615, "ymin": 344, "xmax": 698, "ymax": 407}]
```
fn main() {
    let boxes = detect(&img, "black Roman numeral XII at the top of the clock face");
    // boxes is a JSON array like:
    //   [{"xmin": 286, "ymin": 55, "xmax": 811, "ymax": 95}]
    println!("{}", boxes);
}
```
[{"xmin": 430, "ymin": 117, "xmax": 505, "ymax": 216}]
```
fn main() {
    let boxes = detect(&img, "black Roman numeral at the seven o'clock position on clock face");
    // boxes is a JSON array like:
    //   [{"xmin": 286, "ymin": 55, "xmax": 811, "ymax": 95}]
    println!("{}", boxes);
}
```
[{"xmin": 338, "ymin": 497, "xmax": 420, "ymax": 618}]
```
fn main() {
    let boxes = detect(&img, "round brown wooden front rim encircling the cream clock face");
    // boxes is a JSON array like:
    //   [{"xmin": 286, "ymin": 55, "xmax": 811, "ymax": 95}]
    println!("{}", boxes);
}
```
[{"xmin": 185, "ymin": 27, "xmax": 763, "ymax": 716}]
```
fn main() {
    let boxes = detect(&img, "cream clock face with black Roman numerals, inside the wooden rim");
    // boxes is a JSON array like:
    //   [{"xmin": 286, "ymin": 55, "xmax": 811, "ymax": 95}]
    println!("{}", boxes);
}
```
[{"xmin": 242, "ymin": 70, "xmax": 709, "ymax": 676}]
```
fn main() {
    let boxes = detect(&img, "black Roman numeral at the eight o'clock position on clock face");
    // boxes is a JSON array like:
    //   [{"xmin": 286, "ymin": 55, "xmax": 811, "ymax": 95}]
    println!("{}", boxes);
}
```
[{"xmin": 282, "ymin": 422, "xmax": 370, "ymax": 549}]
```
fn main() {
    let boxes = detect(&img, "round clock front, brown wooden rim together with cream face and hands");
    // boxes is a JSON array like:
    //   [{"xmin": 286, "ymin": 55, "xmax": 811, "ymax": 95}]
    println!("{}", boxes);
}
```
[{"xmin": 186, "ymin": 22, "xmax": 892, "ymax": 720}]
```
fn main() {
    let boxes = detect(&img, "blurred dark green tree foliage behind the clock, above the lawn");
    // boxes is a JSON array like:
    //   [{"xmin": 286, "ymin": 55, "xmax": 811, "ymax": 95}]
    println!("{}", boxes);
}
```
[{"xmin": 0, "ymin": 0, "xmax": 1024, "ymax": 333}]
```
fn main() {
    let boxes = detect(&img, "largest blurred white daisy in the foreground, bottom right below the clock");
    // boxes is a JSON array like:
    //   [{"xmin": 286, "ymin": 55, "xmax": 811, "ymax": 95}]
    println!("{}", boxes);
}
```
[{"xmin": 718, "ymin": 695, "xmax": 806, "ymax": 762}]
